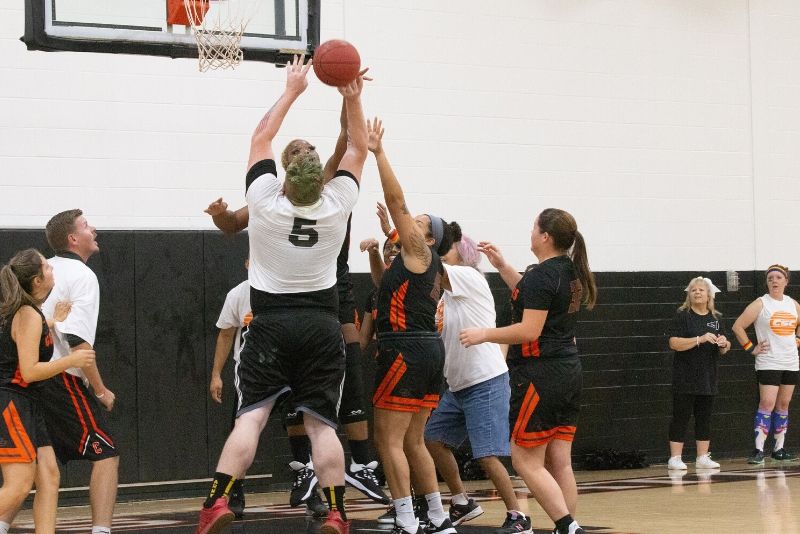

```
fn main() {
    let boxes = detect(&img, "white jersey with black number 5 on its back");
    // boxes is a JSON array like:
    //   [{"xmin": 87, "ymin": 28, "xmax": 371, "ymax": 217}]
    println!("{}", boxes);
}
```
[{"xmin": 246, "ymin": 160, "xmax": 358, "ymax": 293}]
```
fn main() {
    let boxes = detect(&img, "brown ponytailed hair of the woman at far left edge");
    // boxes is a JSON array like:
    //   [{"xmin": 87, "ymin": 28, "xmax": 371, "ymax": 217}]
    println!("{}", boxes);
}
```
[{"xmin": 0, "ymin": 248, "xmax": 42, "ymax": 323}]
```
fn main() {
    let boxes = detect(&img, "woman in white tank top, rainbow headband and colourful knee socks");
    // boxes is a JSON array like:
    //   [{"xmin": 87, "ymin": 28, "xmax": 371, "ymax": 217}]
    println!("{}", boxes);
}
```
[{"xmin": 733, "ymin": 264, "xmax": 800, "ymax": 465}]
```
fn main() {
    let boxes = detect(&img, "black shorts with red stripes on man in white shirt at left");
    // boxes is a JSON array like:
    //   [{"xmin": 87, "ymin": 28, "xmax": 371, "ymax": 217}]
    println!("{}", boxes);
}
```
[{"xmin": 41, "ymin": 372, "xmax": 119, "ymax": 463}]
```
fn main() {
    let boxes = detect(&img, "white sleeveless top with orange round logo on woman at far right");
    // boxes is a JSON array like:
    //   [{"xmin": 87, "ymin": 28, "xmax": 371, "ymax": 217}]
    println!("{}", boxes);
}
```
[{"xmin": 755, "ymin": 295, "xmax": 800, "ymax": 371}]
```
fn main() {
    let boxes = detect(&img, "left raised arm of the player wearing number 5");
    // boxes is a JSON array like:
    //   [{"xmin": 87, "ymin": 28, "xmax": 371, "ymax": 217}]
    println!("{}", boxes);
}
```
[{"xmin": 247, "ymin": 55, "xmax": 311, "ymax": 169}]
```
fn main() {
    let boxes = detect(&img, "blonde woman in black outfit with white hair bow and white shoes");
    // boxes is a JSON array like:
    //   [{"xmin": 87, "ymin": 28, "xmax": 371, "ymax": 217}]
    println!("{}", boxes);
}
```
[{"xmin": 667, "ymin": 276, "xmax": 731, "ymax": 470}]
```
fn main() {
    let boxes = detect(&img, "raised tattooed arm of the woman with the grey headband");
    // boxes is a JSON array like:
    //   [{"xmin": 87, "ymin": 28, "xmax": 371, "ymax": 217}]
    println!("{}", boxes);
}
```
[{"xmin": 367, "ymin": 117, "xmax": 431, "ymax": 273}]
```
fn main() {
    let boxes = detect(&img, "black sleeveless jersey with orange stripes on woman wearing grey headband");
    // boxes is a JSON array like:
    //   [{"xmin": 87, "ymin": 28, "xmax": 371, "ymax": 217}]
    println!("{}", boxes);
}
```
[{"xmin": 375, "ymin": 251, "xmax": 442, "ymax": 334}]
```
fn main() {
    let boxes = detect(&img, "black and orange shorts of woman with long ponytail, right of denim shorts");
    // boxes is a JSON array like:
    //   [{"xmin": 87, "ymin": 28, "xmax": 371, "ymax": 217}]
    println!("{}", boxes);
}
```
[{"xmin": 509, "ymin": 357, "xmax": 583, "ymax": 448}]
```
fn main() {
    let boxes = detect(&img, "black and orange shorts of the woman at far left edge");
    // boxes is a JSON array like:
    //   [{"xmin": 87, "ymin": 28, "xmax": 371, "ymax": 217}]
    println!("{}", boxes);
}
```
[{"xmin": 0, "ymin": 388, "xmax": 51, "ymax": 464}]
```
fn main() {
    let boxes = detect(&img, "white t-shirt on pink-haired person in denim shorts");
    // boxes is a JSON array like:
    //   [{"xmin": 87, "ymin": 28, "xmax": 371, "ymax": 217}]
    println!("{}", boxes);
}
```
[{"xmin": 436, "ymin": 265, "xmax": 508, "ymax": 391}]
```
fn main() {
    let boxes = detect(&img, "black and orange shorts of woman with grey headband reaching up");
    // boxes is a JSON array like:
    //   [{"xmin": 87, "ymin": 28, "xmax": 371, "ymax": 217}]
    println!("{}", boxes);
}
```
[{"xmin": 372, "ymin": 332, "xmax": 444, "ymax": 413}]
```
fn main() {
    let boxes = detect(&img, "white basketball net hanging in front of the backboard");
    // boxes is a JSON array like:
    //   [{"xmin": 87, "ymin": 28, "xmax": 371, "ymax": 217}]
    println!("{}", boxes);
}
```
[{"xmin": 183, "ymin": 0, "xmax": 259, "ymax": 72}]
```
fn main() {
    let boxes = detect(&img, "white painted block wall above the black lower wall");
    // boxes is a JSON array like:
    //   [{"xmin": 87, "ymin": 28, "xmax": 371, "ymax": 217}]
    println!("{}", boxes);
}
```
[{"xmin": 0, "ymin": 0, "xmax": 800, "ymax": 271}]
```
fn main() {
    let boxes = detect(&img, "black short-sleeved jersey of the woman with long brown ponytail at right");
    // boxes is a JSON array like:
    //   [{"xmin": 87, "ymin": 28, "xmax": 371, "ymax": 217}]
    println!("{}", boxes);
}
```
[{"xmin": 508, "ymin": 256, "xmax": 583, "ymax": 363}]
